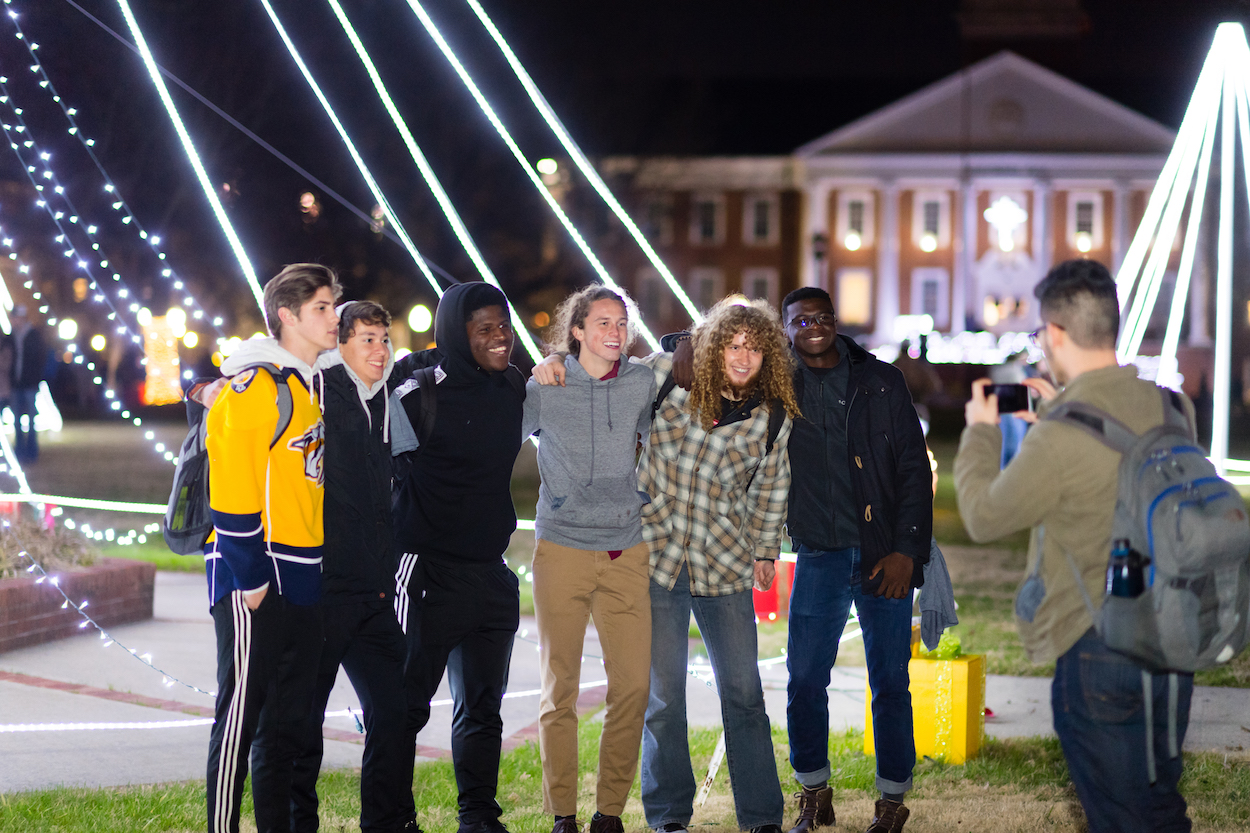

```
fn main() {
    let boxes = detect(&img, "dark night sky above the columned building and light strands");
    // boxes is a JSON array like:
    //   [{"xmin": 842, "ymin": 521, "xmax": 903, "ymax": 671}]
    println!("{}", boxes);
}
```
[{"xmin": 0, "ymin": 0, "xmax": 1250, "ymax": 331}]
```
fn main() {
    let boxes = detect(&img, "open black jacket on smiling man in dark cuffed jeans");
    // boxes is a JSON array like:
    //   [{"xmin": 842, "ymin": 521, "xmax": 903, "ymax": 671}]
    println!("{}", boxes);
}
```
[{"xmin": 789, "ymin": 335, "xmax": 933, "ymax": 590}]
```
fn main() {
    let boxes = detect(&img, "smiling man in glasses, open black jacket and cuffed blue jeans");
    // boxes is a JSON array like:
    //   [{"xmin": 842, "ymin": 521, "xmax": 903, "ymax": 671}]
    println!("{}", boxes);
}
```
[{"xmin": 781, "ymin": 286, "xmax": 933, "ymax": 833}]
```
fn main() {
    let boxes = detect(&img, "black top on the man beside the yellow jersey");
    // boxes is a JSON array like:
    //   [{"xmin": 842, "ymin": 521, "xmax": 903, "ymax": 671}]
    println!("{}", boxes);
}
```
[{"xmin": 321, "ymin": 364, "xmax": 398, "ymax": 604}]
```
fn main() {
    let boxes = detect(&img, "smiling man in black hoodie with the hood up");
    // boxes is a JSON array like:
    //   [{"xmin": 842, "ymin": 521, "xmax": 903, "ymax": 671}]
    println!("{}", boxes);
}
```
[{"xmin": 391, "ymin": 283, "xmax": 525, "ymax": 833}]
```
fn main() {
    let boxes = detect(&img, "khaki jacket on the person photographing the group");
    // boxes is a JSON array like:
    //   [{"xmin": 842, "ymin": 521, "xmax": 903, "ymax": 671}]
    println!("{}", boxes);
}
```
[{"xmin": 955, "ymin": 365, "xmax": 1194, "ymax": 663}]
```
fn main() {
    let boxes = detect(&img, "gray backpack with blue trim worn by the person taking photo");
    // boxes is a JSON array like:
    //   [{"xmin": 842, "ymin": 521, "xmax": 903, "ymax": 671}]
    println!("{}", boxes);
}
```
[{"xmin": 1045, "ymin": 388, "xmax": 1250, "ymax": 673}]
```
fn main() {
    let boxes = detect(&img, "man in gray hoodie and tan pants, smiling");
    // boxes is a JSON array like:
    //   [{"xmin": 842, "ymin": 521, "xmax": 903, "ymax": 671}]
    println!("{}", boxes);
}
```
[{"xmin": 521, "ymin": 285, "xmax": 655, "ymax": 833}]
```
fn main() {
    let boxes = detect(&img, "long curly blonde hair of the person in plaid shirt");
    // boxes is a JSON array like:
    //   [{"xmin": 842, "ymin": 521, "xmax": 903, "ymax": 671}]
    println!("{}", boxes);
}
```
[{"xmin": 686, "ymin": 295, "xmax": 799, "ymax": 432}]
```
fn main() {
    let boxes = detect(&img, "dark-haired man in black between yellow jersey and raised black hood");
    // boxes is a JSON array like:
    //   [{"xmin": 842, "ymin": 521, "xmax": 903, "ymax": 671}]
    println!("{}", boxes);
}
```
[{"xmin": 291, "ymin": 301, "xmax": 418, "ymax": 833}]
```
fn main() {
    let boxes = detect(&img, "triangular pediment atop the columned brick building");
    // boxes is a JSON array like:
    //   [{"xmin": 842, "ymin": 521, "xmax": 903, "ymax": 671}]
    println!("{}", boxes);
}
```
[{"xmin": 796, "ymin": 51, "xmax": 1176, "ymax": 159}]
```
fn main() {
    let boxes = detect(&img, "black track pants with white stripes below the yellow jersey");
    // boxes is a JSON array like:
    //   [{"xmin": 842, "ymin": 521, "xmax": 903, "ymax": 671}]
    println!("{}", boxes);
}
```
[{"xmin": 208, "ymin": 588, "xmax": 321, "ymax": 833}]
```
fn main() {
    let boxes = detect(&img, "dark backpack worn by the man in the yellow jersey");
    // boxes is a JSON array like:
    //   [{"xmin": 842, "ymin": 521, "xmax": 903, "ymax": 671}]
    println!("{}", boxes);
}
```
[{"xmin": 161, "ymin": 361, "xmax": 293, "ymax": 555}]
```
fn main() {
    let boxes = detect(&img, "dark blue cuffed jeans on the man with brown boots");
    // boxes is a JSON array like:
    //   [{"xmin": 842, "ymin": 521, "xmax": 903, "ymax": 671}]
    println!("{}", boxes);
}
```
[{"xmin": 785, "ymin": 544, "xmax": 916, "ymax": 793}]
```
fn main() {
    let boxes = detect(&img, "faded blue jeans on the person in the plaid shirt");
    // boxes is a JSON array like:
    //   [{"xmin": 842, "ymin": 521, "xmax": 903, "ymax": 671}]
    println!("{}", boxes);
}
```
[{"xmin": 643, "ymin": 565, "xmax": 783, "ymax": 830}]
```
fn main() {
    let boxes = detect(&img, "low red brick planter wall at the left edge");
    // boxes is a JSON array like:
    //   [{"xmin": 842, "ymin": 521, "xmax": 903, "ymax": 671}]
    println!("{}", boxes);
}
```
[{"xmin": 0, "ymin": 558, "xmax": 156, "ymax": 652}]
